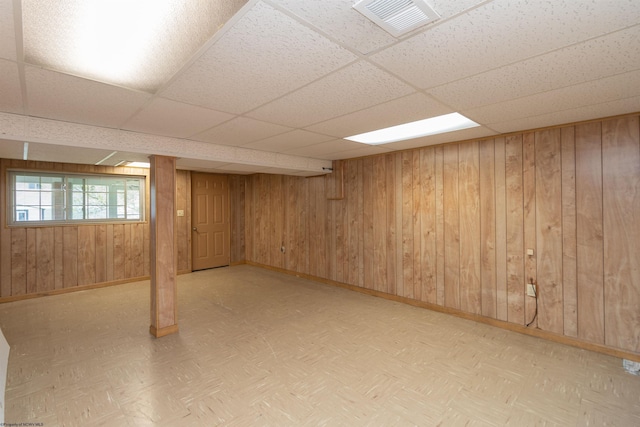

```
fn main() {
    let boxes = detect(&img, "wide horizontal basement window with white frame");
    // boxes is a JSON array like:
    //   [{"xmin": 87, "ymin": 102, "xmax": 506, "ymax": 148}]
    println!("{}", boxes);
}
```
[{"xmin": 7, "ymin": 170, "xmax": 145, "ymax": 226}]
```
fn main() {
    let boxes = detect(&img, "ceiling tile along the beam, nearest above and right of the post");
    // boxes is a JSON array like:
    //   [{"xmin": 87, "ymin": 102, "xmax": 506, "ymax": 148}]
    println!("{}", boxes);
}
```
[{"xmin": 122, "ymin": 98, "xmax": 235, "ymax": 138}]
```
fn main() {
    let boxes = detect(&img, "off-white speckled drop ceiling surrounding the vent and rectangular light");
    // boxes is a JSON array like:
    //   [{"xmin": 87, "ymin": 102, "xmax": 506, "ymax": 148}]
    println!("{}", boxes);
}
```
[{"xmin": 0, "ymin": 0, "xmax": 640, "ymax": 176}]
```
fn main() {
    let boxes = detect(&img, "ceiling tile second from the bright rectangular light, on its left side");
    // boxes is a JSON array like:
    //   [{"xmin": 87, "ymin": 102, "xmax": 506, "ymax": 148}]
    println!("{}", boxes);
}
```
[{"xmin": 248, "ymin": 61, "xmax": 414, "ymax": 128}]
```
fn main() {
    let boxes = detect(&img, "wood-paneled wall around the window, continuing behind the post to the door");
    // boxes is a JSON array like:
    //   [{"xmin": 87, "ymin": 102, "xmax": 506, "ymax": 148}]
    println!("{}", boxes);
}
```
[{"xmin": 0, "ymin": 159, "xmax": 191, "ymax": 298}]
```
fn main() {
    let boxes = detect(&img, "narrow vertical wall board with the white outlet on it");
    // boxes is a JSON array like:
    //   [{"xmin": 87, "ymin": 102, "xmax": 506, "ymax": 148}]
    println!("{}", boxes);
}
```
[{"xmin": 522, "ymin": 132, "xmax": 536, "ymax": 326}]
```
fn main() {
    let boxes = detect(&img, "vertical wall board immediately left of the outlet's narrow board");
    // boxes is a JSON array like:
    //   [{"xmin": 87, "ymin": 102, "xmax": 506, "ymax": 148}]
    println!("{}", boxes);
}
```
[{"xmin": 505, "ymin": 135, "xmax": 524, "ymax": 324}]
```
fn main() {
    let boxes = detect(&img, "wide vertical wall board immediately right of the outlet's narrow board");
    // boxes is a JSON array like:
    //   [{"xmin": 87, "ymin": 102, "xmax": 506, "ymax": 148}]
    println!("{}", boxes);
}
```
[{"xmin": 535, "ymin": 129, "xmax": 564, "ymax": 334}]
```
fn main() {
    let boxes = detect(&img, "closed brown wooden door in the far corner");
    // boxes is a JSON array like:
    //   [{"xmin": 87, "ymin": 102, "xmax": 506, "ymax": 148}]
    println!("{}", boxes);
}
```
[{"xmin": 191, "ymin": 172, "xmax": 231, "ymax": 270}]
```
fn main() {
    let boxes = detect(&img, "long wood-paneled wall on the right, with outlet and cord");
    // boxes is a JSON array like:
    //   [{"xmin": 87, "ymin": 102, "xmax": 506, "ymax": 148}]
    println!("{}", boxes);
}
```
[{"xmin": 245, "ymin": 115, "xmax": 640, "ymax": 353}]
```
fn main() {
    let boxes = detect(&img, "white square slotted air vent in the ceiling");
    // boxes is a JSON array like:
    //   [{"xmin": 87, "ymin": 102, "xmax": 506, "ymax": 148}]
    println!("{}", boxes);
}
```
[{"xmin": 353, "ymin": 0, "xmax": 440, "ymax": 37}]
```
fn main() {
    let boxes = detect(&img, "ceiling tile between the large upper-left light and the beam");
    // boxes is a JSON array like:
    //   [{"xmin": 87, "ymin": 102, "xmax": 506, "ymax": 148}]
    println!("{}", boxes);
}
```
[{"xmin": 25, "ymin": 67, "xmax": 150, "ymax": 127}]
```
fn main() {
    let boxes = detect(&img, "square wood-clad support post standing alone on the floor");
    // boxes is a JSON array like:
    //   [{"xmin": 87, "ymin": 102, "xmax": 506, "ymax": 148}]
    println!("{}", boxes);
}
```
[{"xmin": 149, "ymin": 156, "xmax": 178, "ymax": 338}]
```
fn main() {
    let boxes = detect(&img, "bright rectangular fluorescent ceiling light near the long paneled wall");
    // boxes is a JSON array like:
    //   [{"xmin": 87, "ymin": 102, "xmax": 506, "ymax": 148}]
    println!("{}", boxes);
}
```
[{"xmin": 344, "ymin": 113, "xmax": 480, "ymax": 145}]
